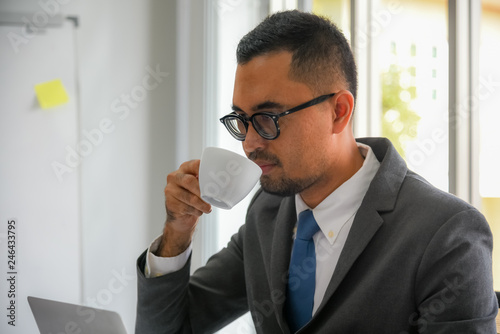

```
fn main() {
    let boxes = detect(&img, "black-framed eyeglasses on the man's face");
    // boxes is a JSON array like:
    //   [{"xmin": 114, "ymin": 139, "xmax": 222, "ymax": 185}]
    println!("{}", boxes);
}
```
[{"xmin": 220, "ymin": 93, "xmax": 335, "ymax": 141}]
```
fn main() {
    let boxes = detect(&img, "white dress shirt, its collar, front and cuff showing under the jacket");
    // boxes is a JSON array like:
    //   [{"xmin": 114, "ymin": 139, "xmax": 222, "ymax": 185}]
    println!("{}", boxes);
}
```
[{"xmin": 145, "ymin": 143, "xmax": 380, "ymax": 313}]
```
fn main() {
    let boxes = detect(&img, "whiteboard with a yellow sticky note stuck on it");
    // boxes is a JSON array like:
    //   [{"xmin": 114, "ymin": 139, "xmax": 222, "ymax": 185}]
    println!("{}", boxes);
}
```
[{"xmin": 0, "ymin": 21, "xmax": 81, "ymax": 334}]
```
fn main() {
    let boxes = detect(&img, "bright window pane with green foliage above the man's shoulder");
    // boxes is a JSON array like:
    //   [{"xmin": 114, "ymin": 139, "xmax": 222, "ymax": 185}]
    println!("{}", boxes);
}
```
[{"xmin": 372, "ymin": 0, "xmax": 448, "ymax": 191}]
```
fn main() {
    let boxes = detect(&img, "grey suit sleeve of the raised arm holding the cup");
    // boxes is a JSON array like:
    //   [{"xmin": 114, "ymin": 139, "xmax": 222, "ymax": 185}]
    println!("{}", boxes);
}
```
[{"xmin": 136, "ymin": 225, "xmax": 248, "ymax": 334}]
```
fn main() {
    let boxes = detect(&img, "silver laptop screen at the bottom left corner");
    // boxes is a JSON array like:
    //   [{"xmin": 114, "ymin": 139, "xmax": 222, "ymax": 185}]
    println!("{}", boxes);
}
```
[{"xmin": 28, "ymin": 296, "xmax": 127, "ymax": 334}]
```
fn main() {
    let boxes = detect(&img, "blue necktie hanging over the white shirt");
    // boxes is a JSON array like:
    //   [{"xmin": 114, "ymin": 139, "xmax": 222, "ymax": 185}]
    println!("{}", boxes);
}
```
[{"xmin": 285, "ymin": 210, "xmax": 319, "ymax": 332}]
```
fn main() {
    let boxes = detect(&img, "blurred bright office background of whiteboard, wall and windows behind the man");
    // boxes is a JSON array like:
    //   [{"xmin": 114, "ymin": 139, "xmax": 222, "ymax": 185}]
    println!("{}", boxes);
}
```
[{"xmin": 0, "ymin": 0, "xmax": 500, "ymax": 333}]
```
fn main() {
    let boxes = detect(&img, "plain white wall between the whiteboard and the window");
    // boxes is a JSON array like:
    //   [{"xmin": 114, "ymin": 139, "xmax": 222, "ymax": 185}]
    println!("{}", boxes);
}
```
[{"xmin": 0, "ymin": 0, "xmax": 177, "ymax": 333}]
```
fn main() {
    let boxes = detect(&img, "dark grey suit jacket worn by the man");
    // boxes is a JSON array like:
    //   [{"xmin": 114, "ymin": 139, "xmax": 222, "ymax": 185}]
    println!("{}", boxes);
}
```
[{"xmin": 136, "ymin": 138, "xmax": 498, "ymax": 334}]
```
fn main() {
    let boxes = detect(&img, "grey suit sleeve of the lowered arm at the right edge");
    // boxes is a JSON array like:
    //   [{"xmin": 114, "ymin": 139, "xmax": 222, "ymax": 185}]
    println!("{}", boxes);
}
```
[{"xmin": 409, "ymin": 209, "xmax": 498, "ymax": 334}]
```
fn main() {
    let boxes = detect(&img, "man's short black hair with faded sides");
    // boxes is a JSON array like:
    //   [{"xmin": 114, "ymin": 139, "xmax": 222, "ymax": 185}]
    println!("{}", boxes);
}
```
[{"xmin": 236, "ymin": 10, "xmax": 358, "ymax": 99}]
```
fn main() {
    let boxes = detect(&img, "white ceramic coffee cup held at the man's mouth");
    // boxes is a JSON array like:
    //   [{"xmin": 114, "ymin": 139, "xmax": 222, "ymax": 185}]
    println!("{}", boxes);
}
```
[{"xmin": 199, "ymin": 147, "xmax": 262, "ymax": 209}]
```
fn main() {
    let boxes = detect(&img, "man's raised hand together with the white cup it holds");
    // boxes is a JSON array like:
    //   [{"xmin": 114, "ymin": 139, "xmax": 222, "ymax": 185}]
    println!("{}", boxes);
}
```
[{"xmin": 156, "ymin": 147, "xmax": 262, "ymax": 257}]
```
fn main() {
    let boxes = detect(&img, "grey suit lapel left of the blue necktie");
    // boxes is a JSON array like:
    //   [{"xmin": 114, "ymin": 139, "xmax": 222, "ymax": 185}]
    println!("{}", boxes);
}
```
[{"xmin": 270, "ymin": 196, "xmax": 297, "ymax": 332}]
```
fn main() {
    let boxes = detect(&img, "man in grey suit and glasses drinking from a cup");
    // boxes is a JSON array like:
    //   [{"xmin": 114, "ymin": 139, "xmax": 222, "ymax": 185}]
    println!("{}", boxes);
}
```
[{"xmin": 136, "ymin": 11, "xmax": 498, "ymax": 334}]
